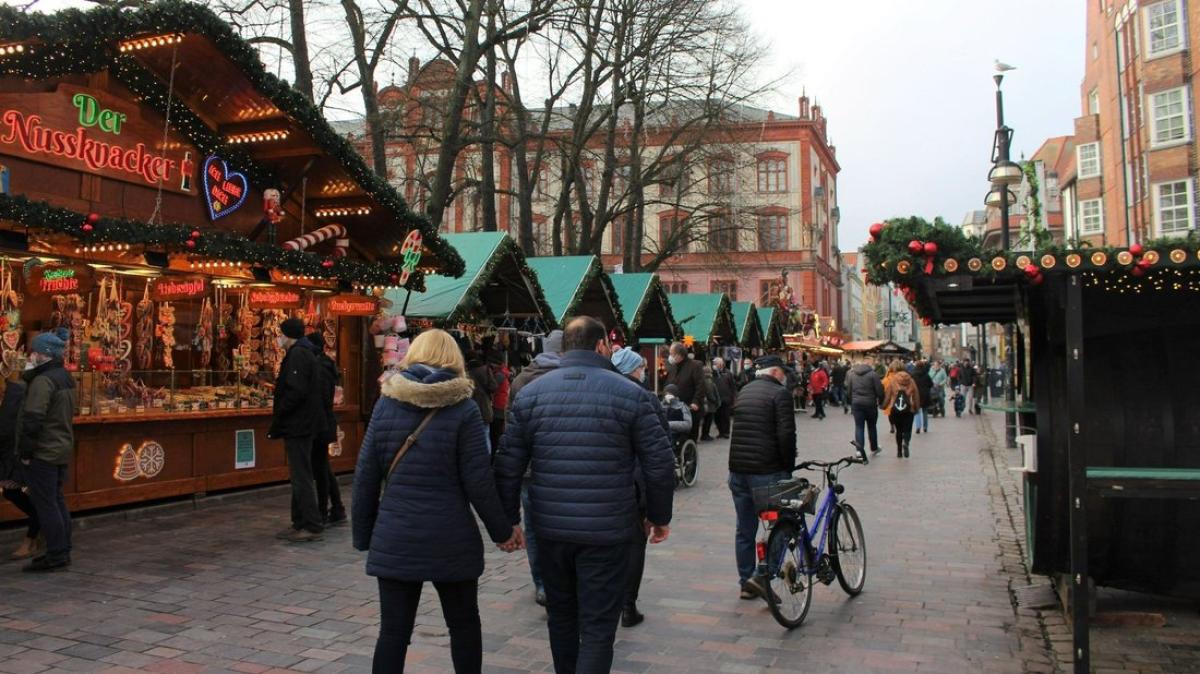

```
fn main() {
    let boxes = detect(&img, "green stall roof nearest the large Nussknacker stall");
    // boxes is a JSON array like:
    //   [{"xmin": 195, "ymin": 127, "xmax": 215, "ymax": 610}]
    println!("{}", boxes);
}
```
[{"xmin": 398, "ymin": 231, "xmax": 558, "ymax": 327}]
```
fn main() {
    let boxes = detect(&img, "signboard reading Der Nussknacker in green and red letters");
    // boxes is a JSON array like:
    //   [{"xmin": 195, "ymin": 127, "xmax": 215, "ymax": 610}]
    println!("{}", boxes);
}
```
[{"xmin": 0, "ymin": 84, "xmax": 196, "ymax": 193}]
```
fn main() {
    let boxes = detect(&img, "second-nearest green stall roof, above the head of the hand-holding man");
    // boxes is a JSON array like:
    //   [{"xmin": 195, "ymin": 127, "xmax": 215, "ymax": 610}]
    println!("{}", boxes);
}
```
[{"xmin": 528, "ymin": 255, "xmax": 629, "ymax": 335}]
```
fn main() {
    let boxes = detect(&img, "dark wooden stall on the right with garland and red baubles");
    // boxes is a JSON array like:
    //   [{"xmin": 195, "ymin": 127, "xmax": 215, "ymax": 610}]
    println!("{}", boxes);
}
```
[{"xmin": 865, "ymin": 214, "xmax": 1200, "ymax": 672}]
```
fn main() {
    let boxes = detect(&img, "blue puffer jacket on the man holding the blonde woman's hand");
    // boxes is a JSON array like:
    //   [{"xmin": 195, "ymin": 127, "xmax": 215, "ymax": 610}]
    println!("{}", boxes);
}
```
[{"xmin": 496, "ymin": 351, "xmax": 674, "ymax": 546}]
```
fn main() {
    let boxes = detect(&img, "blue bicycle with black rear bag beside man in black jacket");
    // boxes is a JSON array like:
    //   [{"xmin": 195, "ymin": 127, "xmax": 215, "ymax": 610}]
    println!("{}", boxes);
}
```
[{"xmin": 754, "ymin": 443, "xmax": 866, "ymax": 630}]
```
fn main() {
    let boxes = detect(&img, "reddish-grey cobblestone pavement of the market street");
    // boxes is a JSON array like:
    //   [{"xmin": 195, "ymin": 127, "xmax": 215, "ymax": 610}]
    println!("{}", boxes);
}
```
[{"xmin": 0, "ymin": 408, "xmax": 1061, "ymax": 674}]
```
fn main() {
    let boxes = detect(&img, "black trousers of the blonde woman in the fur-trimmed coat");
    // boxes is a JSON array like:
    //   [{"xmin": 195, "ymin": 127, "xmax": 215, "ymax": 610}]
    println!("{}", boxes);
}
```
[{"xmin": 371, "ymin": 570, "xmax": 484, "ymax": 674}]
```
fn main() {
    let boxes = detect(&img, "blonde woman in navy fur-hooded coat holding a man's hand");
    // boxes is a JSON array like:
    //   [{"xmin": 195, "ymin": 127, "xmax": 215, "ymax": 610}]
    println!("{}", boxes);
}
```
[{"xmin": 352, "ymin": 330, "xmax": 523, "ymax": 674}]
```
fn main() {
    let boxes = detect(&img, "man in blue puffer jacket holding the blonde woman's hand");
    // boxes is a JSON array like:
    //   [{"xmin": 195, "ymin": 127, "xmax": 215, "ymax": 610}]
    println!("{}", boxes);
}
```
[{"xmin": 496, "ymin": 317, "xmax": 674, "ymax": 674}]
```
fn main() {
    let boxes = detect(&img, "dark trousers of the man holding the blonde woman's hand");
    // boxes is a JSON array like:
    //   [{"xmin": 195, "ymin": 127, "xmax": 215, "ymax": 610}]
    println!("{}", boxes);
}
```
[{"xmin": 538, "ymin": 538, "xmax": 632, "ymax": 674}]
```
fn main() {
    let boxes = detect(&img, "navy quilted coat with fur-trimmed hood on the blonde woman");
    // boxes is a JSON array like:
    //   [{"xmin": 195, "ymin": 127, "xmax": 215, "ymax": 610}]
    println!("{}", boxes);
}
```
[{"xmin": 352, "ymin": 365, "xmax": 512, "ymax": 582}]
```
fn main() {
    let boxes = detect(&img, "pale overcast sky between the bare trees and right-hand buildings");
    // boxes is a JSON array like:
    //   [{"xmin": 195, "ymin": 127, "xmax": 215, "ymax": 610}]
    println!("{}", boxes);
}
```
[{"xmin": 743, "ymin": 0, "xmax": 1086, "ymax": 251}]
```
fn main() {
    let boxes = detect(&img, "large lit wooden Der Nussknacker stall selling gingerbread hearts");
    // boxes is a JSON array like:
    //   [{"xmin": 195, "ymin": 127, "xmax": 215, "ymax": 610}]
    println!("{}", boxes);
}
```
[{"xmin": 0, "ymin": 1, "xmax": 462, "ymax": 518}]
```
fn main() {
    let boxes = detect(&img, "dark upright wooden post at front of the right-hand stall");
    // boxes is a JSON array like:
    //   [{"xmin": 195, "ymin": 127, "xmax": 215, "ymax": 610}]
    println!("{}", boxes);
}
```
[{"xmin": 1066, "ymin": 269, "xmax": 1090, "ymax": 674}]
